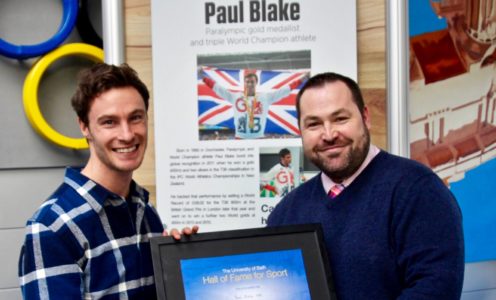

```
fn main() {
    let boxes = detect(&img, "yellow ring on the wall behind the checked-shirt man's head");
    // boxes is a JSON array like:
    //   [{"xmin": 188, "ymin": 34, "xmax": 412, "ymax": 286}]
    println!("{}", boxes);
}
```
[{"xmin": 23, "ymin": 43, "xmax": 104, "ymax": 149}]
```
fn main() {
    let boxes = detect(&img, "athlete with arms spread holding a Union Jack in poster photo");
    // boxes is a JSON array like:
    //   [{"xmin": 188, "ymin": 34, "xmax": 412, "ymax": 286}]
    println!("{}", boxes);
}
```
[{"xmin": 203, "ymin": 70, "xmax": 306, "ymax": 139}]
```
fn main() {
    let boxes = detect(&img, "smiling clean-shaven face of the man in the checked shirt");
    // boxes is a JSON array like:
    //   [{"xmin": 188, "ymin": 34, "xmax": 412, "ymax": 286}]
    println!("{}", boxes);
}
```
[{"xmin": 80, "ymin": 87, "xmax": 148, "ymax": 175}]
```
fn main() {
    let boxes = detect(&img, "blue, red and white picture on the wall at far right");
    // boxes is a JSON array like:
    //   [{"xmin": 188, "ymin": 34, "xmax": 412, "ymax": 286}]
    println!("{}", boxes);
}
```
[{"xmin": 409, "ymin": 0, "xmax": 496, "ymax": 262}]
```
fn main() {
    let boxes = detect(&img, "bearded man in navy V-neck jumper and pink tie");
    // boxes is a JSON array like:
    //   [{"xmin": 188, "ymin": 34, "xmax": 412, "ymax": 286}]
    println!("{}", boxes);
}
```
[{"xmin": 268, "ymin": 73, "xmax": 464, "ymax": 300}]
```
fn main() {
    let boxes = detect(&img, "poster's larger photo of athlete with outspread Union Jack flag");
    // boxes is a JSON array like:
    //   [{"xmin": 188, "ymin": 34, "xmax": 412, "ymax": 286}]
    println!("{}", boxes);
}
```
[{"xmin": 197, "ymin": 50, "xmax": 310, "ymax": 140}]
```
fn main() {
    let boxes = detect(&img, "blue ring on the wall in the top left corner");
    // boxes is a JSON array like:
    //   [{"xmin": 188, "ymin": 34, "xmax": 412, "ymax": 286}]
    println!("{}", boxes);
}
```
[{"xmin": 0, "ymin": 0, "xmax": 79, "ymax": 59}]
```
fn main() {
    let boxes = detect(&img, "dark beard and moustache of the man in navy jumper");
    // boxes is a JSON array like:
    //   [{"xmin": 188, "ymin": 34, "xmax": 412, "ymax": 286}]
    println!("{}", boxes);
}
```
[{"xmin": 309, "ymin": 126, "xmax": 370, "ymax": 183}]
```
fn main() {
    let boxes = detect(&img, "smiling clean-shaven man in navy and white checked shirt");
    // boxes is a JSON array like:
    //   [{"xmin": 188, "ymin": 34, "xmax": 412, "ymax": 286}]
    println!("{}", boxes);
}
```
[{"xmin": 19, "ymin": 64, "xmax": 198, "ymax": 299}]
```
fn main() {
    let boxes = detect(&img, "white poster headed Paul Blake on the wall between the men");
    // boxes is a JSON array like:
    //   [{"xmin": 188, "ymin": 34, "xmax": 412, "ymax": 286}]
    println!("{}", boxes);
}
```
[{"xmin": 152, "ymin": 0, "xmax": 357, "ymax": 232}]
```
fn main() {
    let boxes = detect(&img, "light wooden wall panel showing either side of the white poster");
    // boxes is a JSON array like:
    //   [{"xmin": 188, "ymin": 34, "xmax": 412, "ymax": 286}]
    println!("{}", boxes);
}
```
[{"xmin": 124, "ymin": 0, "xmax": 387, "ymax": 201}]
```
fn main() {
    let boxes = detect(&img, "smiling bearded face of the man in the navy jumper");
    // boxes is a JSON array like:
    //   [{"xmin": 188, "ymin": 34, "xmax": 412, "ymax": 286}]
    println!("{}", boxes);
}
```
[{"xmin": 300, "ymin": 81, "xmax": 370, "ymax": 182}]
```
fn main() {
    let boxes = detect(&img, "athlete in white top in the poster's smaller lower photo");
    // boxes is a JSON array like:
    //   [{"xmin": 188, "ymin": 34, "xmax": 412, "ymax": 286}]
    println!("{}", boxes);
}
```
[{"xmin": 262, "ymin": 148, "xmax": 294, "ymax": 197}]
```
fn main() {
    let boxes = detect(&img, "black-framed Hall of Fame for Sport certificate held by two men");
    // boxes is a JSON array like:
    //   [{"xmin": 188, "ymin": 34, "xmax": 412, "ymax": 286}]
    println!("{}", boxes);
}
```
[{"xmin": 151, "ymin": 224, "xmax": 335, "ymax": 300}]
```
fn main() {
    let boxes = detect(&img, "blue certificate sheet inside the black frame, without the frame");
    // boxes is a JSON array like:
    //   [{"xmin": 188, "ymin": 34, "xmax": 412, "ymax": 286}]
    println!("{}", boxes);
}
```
[{"xmin": 180, "ymin": 249, "xmax": 311, "ymax": 300}]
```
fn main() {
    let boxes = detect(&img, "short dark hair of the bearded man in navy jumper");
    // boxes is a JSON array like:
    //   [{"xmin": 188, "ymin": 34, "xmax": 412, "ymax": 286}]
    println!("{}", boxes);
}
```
[{"xmin": 296, "ymin": 72, "xmax": 365, "ymax": 124}]
